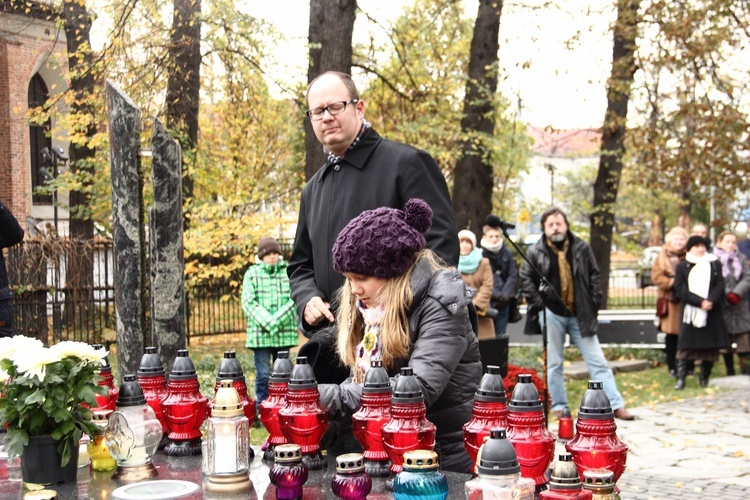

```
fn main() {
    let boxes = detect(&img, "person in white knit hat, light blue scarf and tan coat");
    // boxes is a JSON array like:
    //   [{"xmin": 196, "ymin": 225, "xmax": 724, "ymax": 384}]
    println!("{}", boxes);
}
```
[{"xmin": 458, "ymin": 229, "xmax": 498, "ymax": 340}]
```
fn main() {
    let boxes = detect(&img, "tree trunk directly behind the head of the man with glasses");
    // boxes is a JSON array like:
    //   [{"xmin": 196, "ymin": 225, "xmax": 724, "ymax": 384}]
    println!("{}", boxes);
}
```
[{"xmin": 305, "ymin": 0, "xmax": 357, "ymax": 180}]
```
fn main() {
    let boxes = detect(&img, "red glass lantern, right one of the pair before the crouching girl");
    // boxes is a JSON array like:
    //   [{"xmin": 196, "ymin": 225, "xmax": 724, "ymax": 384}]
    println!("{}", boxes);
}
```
[{"xmin": 381, "ymin": 367, "xmax": 436, "ymax": 490}]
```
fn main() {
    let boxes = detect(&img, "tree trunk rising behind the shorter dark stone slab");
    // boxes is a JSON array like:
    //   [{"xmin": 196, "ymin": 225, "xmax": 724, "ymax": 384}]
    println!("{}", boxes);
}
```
[{"xmin": 166, "ymin": 0, "xmax": 201, "ymax": 229}]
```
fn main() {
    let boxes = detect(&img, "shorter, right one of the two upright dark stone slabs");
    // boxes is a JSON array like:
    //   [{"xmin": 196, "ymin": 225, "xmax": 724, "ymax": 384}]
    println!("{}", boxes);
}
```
[{"xmin": 149, "ymin": 119, "xmax": 185, "ymax": 369}]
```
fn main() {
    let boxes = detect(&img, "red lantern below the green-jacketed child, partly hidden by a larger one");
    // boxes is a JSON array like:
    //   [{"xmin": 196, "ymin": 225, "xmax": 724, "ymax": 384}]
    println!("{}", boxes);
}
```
[{"xmin": 260, "ymin": 351, "xmax": 294, "ymax": 461}]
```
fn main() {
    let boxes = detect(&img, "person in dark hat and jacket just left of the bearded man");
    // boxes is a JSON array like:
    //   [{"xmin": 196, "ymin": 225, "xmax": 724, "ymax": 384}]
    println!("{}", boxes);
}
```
[{"xmin": 481, "ymin": 214, "xmax": 518, "ymax": 337}]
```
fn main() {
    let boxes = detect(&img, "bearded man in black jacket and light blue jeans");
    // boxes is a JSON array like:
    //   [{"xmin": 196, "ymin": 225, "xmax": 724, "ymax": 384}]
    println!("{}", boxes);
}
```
[{"xmin": 521, "ymin": 207, "xmax": 635, "ymax": 420}]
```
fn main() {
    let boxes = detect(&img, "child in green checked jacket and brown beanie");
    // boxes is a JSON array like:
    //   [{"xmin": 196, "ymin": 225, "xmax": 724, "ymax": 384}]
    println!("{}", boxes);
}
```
[{"xmin": 241, "ymin": 236, "xmax": 297, "ymax": 405}]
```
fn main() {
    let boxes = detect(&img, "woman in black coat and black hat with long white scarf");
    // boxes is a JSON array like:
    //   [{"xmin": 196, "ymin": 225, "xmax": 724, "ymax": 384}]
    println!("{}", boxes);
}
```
[{"xmin": 673, "ymin": 235, "xmax": 729, "ymax": 390}]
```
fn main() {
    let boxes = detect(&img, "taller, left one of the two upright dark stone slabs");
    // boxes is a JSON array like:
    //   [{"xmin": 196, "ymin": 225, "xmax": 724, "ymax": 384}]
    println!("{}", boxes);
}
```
[{"xmin": 107, "ymin": 81, "xmax": 146, "ymax": 381}]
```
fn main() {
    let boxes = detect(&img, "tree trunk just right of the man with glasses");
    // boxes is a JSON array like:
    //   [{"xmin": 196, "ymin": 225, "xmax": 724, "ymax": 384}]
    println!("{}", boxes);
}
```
[{"xmin": 453, "ymin": 0, "xmax": 503, "ymax": 234}]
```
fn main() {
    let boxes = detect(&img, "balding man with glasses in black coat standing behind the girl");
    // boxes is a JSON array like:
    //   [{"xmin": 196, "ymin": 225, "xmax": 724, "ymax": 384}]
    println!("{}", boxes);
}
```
[{"xmin": 288, "ymin": 72, "xmax": 459, "ymax": 382}]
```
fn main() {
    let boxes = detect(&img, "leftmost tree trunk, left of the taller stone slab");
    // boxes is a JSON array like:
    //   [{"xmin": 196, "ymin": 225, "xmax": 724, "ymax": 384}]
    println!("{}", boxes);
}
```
[{"xmin": 63, "ymin": 0, "xmax": 97, "ymax": 328}]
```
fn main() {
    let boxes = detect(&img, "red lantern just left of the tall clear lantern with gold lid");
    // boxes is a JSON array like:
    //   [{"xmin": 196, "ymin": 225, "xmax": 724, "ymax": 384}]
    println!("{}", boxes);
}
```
[{"xmin": 161, "ymin": 349, "xmax": 208, "ymax": 456}]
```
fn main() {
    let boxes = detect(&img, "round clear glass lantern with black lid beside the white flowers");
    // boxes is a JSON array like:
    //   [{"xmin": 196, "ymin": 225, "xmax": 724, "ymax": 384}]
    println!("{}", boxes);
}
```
[{"xmin": 104, "ymin": 374, "xmax": 162, "ymax": 482}]
